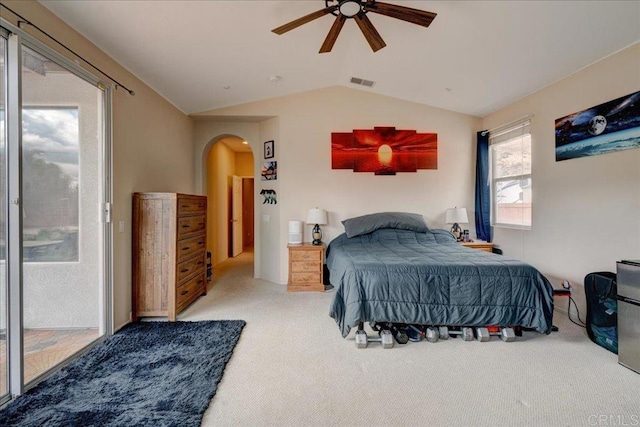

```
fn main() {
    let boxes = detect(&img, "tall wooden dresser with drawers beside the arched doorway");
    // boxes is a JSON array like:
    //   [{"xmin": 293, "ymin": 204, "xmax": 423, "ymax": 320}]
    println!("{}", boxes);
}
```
[{"xmin": 132, "ymin": 193, "xmax": 207, "ymax": 322}]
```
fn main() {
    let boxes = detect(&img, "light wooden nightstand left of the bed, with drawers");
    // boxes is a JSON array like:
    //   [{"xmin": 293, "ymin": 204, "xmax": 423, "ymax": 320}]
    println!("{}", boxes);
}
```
[{"xmin": 287, "ymin": 243, "xmax": 325, "ymax": 292}]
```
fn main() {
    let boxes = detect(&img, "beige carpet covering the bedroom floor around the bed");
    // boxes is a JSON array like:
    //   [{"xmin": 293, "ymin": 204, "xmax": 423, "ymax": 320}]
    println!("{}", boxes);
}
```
[{"xmin": 181, "ymin": 254, "xmax": 640, "ymax": 426}]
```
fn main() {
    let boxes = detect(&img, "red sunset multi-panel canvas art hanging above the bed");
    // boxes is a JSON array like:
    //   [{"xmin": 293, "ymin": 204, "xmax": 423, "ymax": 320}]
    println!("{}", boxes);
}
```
[{"xmin": 331, "ymin": 127, "xmax": 438, "ymax": 175}]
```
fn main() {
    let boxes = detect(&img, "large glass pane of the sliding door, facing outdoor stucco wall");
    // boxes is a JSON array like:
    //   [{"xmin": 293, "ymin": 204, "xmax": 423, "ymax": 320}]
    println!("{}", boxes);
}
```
[{"xmin": 21, "ymin": 46, "xmax": 103, "ymax": 384}]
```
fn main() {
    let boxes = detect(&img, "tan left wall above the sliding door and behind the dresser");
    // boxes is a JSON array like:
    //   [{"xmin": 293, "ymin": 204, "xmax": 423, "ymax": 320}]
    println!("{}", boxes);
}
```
[{"xmin": 2, "ymin": 0, "xmax": 195, "ymax": 328}]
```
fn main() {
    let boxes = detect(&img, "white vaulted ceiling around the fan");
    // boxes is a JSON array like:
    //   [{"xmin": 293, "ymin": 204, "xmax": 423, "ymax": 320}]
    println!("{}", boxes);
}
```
[{"xmin": 41, "ymin": 0, "xmax": 640, "ymax": 117}]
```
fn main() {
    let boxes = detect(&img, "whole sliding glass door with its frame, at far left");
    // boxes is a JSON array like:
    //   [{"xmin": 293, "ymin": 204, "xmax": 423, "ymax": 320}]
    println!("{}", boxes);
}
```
[{"xmin": 0, "ymin": 22, "xmax": 111, "ymax": 400}]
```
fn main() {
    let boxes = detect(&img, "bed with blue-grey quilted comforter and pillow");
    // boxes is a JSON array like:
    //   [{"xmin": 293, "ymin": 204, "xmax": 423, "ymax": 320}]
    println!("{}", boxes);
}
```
[{"xmin": 327, "ymin": 212, "xmax": 553, "ymax": 337}]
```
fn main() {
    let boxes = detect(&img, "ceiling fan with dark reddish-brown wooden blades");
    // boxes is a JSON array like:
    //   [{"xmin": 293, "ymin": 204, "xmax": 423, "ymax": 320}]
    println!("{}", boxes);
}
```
[{"xmin": 271, "ymin": 0, "xmax": 436, "ymax": 53}]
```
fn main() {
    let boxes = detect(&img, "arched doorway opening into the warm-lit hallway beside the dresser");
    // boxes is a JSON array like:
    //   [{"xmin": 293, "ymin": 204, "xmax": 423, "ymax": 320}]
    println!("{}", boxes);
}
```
[{"xmin": 203, "ymin": 135, "xmax": 255, "ymax": 278}]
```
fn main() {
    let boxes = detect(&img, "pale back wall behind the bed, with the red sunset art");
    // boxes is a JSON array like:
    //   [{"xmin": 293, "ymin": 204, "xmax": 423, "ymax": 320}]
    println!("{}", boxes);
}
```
[{"xmin": 196, "ymin": 87, "xmax": 480, "ymax": 283}]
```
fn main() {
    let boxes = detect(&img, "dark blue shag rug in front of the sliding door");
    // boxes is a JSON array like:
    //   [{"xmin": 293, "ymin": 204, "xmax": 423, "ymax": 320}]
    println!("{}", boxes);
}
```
[{"xmin": 0, "ymin": 320, "xmax": 245, "ymax": 427}]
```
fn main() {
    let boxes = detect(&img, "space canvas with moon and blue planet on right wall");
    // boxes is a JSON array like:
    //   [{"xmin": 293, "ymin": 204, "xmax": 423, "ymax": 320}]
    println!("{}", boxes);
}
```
[{"xmin": 556, "ymin": 92, "xmax": 640, "ymax": 162}]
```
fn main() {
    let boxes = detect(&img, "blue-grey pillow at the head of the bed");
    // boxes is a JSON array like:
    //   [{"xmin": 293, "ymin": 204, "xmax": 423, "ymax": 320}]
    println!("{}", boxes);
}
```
[{"xmin": 342, "ymin": 212, "xmax": 429, "ymax": 238}]
